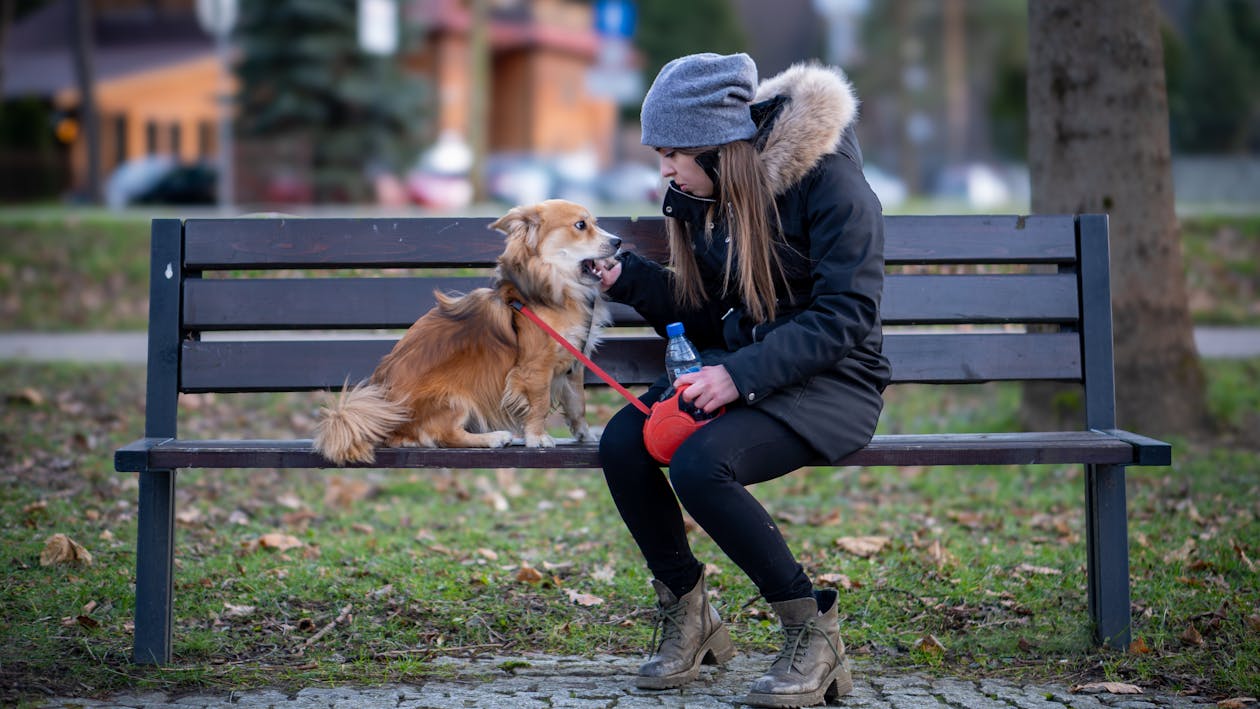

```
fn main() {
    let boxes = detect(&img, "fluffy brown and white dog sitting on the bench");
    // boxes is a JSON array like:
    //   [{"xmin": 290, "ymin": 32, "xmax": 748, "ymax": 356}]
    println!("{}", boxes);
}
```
[{"xmin": 314, "ymin": 199, "xmax": 621, "ymax": 465}]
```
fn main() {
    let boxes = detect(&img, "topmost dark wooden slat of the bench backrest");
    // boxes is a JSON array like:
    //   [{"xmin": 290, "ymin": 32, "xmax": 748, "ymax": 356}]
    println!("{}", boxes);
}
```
[{"xmin": 184, "ymin": 215, "xmax": 1076, "ymax": 271}]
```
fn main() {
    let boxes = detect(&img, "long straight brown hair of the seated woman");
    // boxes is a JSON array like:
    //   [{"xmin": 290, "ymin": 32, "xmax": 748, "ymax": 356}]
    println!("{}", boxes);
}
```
[{"xmin": 665, "ymin": 140, "xmax": 784, "ymax": 322}]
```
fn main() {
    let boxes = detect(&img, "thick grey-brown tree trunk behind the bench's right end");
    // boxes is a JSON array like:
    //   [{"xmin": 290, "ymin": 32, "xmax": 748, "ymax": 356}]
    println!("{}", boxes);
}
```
[{"xmin": 1023, "ymin": 0, "xmax": 1210, "ymax": 436}]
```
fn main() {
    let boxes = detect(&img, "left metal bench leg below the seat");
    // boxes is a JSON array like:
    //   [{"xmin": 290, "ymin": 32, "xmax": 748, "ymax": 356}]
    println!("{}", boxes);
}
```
[{"xmin": 135, "ymin": 470, "xmax": 175, "ymax": 665}]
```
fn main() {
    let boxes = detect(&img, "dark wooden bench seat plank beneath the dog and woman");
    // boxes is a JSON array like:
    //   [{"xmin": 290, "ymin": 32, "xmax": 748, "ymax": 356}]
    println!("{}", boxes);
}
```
[{"xmin": 116, "ymin": 431, "xmax": 1137, "ymax": 470}]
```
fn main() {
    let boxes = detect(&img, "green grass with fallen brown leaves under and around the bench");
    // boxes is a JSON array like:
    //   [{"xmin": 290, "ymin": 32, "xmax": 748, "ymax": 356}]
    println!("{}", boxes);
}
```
[{"xmin": 0, "ymin": 360, "xmax": 1260, "ymax": 699}]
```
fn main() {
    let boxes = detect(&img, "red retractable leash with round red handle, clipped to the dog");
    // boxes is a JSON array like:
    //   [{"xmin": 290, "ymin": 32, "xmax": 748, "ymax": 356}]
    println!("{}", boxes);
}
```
[{"xmin": 512, "ymin": 301, "xmax": 726, "ymax": 465}]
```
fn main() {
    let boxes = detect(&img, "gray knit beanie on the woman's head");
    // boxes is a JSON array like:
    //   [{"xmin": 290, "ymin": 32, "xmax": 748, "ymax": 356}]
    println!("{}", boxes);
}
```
[{"xmin": 639, "ymin": 53, "xmax": 757, "ymax": 147}]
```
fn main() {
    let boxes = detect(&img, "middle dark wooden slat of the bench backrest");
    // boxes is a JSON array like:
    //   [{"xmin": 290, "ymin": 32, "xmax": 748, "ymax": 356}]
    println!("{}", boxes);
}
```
[{"xmin": 184, "ymin": 273, "xmax": 1080, "ymax": 330}]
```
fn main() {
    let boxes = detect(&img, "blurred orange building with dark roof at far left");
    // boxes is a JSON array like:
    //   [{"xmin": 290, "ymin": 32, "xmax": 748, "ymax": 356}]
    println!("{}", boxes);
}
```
[{"xmin": 0, "ymin": 0, "xmax": 219, "ymax": 201}]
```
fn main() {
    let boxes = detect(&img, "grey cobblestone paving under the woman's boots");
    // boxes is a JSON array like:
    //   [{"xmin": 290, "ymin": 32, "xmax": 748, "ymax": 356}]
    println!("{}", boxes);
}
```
[{"xmin": 43, "ymin": 655, "xmax": 1213, "ymax": 709}]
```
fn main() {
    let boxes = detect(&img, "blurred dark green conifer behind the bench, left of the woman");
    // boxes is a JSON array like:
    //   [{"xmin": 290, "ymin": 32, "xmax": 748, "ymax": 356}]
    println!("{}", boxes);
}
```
[{"xmin": 236, "ymin": 0, "xmax": 427, "ymax": 203}]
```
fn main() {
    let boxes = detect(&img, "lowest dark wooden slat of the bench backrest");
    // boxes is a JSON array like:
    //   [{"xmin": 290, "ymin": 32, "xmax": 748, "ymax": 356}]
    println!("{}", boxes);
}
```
[{"xmin": 180, "ymin": 332, "xmax": 1081, "ymax": 392}]
